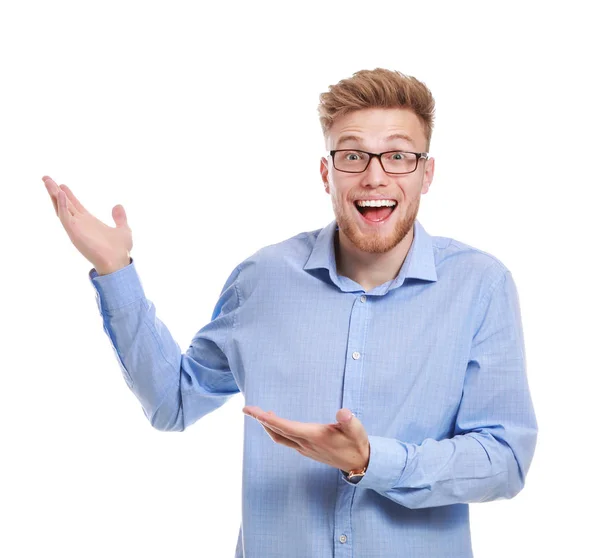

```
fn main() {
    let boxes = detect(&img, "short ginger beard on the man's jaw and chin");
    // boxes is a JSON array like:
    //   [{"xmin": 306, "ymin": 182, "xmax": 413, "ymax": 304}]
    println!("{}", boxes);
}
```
[{"xmin": 331, "ymin": 193, "xmax": 421, "ymax": 254}]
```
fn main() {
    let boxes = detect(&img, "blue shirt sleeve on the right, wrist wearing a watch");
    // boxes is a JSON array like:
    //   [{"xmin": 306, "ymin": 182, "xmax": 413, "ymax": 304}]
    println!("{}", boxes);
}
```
[{"xmin": 342, "ymin": 270, "xmax": 538, "ymax": 508}]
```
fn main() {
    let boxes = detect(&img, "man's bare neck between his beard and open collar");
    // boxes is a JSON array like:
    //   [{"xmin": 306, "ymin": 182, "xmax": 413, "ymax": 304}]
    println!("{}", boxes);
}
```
[{"xmin": 334, "ymin": 227, "xmax": 414, "ymax": 291}]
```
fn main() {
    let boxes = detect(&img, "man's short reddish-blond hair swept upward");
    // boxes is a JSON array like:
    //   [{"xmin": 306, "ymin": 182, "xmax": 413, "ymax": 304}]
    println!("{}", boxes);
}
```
[{"xmin": 317, "ymin": 68, "xmax": 435, "ymax": 151}]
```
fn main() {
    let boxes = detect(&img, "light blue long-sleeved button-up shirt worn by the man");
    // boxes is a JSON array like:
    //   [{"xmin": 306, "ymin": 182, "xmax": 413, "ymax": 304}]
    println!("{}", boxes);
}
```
[{"xmin": 89, "ymin": 220, "xmax": 537, "ymax": 558}]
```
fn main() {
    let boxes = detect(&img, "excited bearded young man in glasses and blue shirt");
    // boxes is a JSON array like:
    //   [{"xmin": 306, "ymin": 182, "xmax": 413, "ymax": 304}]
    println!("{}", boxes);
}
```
[{"xmin": 46, "ymin": 69, "xmax": 537, "ymax": 558}]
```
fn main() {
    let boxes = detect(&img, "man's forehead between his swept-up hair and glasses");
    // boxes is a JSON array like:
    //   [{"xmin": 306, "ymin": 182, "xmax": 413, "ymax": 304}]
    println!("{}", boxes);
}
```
[{"xmin": 328, "ymin": 108, "xmax": 426, "ymax": 150}]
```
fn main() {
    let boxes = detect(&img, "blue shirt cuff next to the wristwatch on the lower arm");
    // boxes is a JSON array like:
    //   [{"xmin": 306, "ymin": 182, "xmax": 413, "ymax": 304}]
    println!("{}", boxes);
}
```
[{"xmin": 340, "ymin": 436, "xmax": 408, "ymax": 493}]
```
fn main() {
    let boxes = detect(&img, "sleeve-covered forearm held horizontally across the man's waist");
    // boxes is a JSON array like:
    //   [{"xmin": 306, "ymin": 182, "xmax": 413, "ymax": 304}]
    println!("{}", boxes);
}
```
[{"xmin": 346, "ymin": 425, "xmax": 537, "ymax": 508}]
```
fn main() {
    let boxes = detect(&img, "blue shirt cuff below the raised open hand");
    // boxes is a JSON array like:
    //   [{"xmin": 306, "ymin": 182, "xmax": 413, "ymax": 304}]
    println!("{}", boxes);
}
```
[{"xmin": 88, "ymin": 256, "xmax": 146, "ymax": 314}]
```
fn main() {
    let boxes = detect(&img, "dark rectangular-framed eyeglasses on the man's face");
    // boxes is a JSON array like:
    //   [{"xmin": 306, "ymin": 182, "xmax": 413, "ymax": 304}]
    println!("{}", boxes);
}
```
[{"xmin": 329, "ymin": 149, "xmax": 429, "ymax": 174}]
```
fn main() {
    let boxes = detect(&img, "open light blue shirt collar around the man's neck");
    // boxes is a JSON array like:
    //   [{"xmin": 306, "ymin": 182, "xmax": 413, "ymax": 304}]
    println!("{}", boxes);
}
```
[{"xmin": 304, "ymin": 219, "xmax": 437, "ymax": 294}]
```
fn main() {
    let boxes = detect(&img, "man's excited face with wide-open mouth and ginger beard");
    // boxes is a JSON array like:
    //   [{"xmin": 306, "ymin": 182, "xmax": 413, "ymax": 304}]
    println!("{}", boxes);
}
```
[{"xmin": 321, "ymin": 108, "xmax": 435, "ymax": 254}]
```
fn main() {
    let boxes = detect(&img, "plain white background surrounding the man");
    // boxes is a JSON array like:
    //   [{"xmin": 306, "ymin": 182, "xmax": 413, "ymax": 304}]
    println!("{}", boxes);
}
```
[{"xmin": 0, "ymin": 1, "xmax": 600, "ymax": 558}]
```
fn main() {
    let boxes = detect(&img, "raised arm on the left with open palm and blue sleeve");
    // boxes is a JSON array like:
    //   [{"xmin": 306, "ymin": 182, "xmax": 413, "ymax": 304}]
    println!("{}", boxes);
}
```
[{"xmin": 43, "ymin": 176, "xmax": 239, "ymax": 431}]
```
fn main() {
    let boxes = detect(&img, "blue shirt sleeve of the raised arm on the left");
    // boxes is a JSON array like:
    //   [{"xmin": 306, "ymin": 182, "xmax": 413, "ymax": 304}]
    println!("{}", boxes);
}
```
[{"xmin": 89, "ymin": 258, "xmax": 240, "ymax": 431}]
